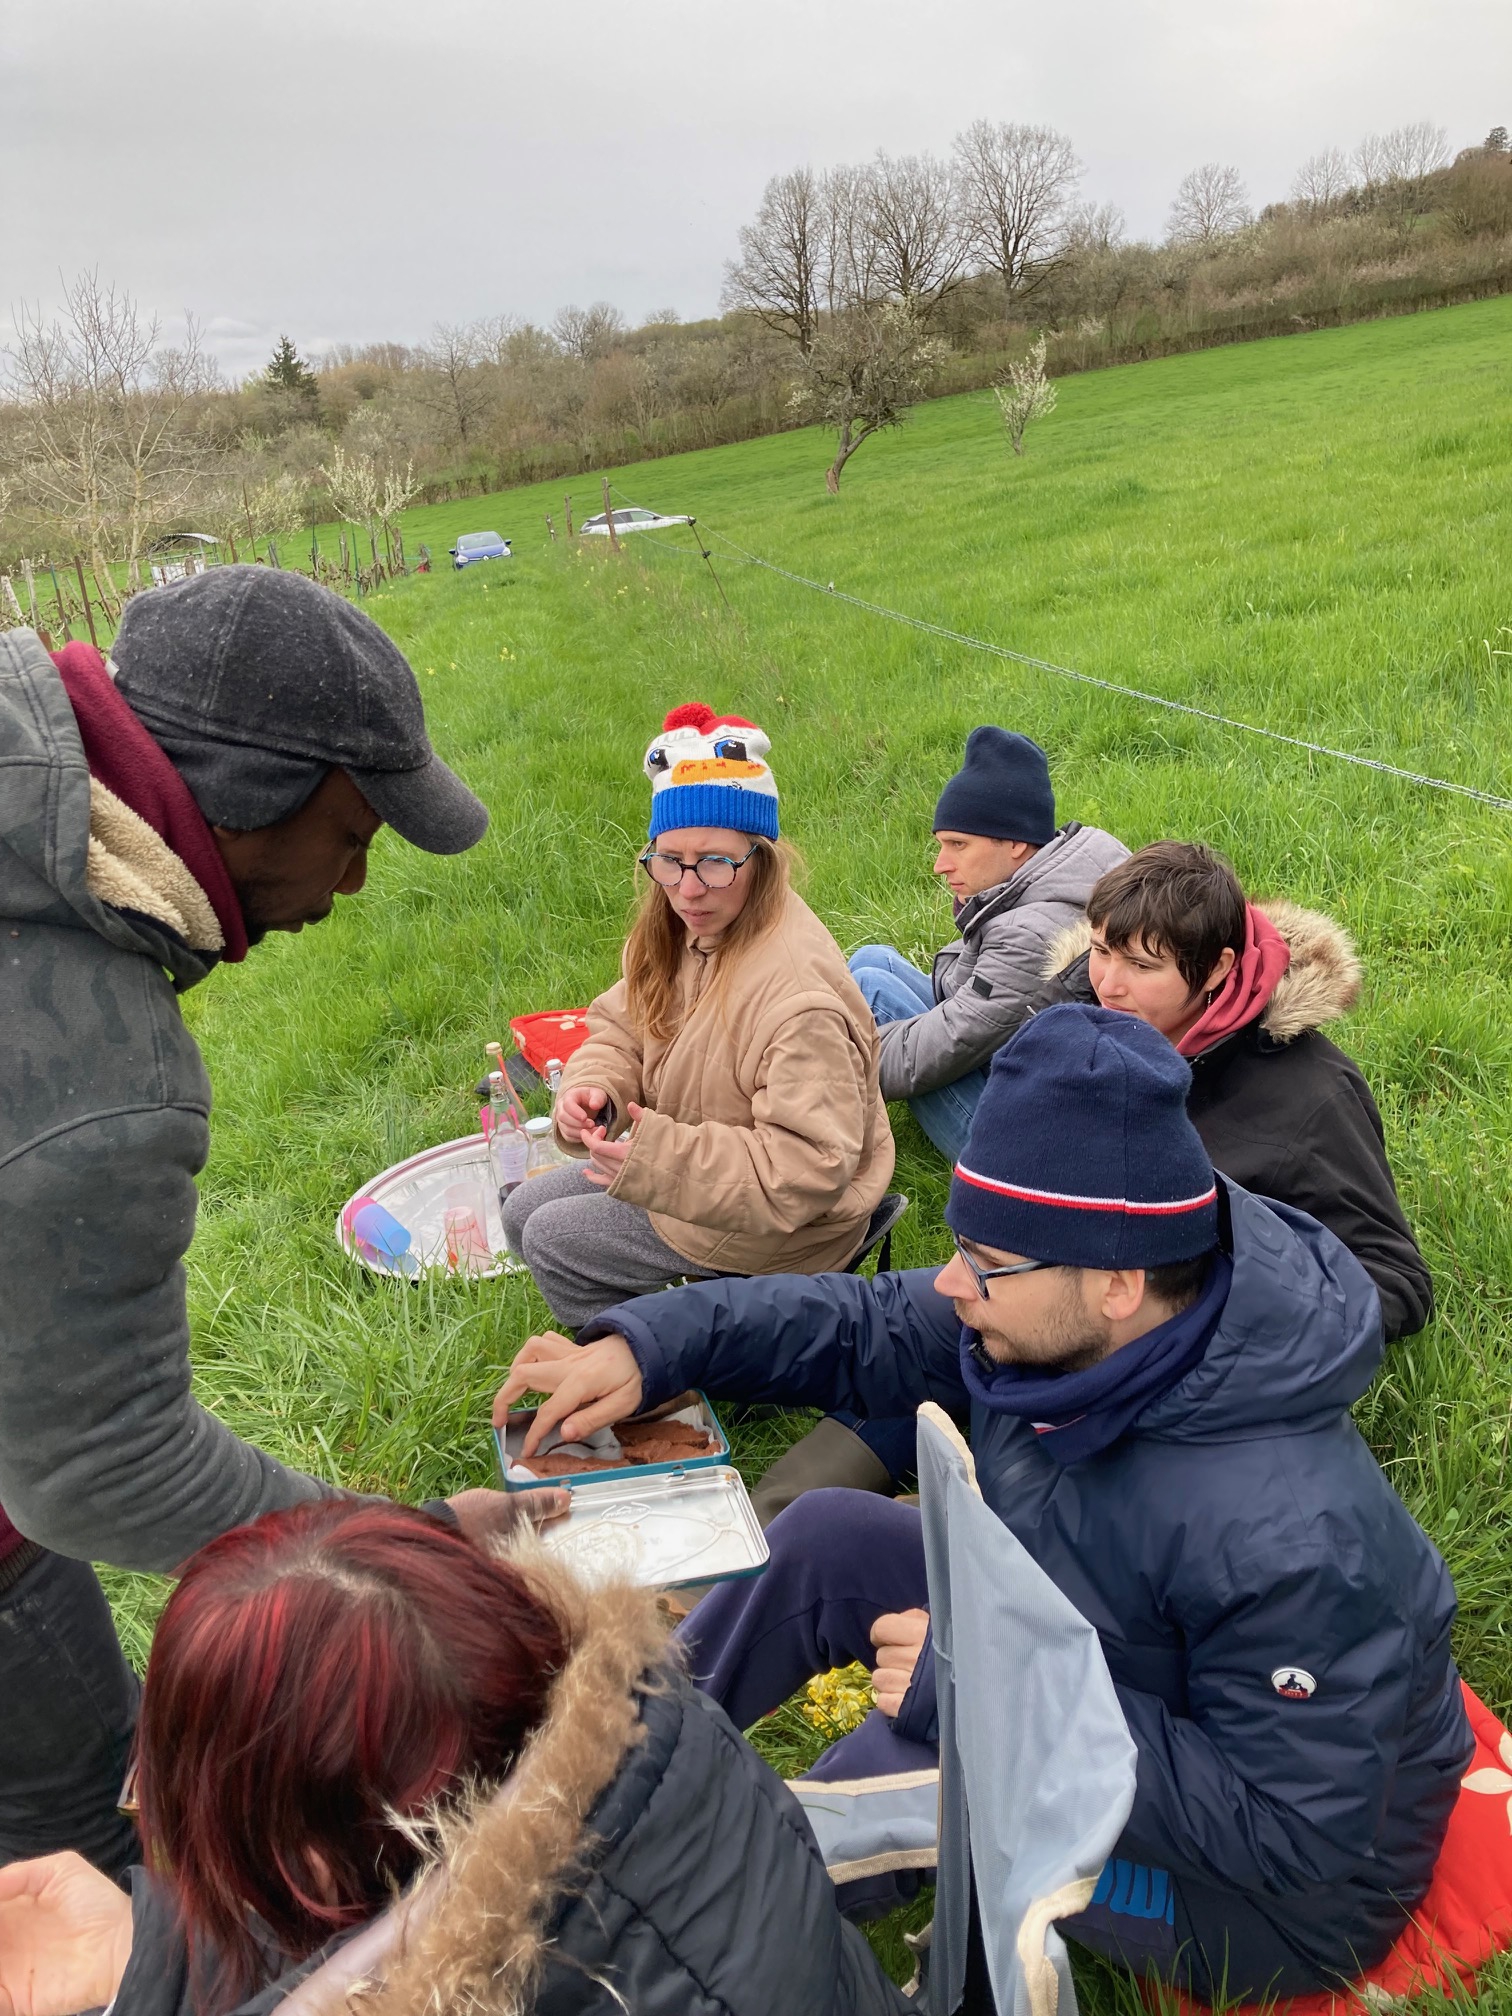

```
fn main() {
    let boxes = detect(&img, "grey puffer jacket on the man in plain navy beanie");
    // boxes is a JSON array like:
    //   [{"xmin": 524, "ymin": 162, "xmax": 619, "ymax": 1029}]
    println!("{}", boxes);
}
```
[{"xmin": 881, "ymin": 818, "xmax": 1129, "ymax": 1099}]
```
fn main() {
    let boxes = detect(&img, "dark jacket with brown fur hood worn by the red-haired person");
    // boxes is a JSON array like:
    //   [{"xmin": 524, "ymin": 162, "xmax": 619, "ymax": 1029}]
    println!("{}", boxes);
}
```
[{"xmin": 113, "ymin": 1579, "xmax": 911, "ymax": 2016}]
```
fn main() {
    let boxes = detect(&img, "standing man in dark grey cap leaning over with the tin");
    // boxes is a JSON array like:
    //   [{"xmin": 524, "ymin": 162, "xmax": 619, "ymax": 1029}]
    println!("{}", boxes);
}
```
[{"xmin": 0, "ymin": 566, "xmax": 552, "ymax": 1875}]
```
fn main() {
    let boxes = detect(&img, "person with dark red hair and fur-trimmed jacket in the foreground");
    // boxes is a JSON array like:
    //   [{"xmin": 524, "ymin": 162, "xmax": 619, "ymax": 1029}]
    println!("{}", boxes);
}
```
[{"xmin": 0, "ymin": 1500, "xmax": 907, "ymax": 2016}]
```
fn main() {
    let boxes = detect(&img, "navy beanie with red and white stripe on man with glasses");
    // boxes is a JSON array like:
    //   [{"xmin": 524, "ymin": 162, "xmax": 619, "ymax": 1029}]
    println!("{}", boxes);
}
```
[{"xmin": 946, "ymin": 1004, "xmax": 1218, "ymax": 1268}]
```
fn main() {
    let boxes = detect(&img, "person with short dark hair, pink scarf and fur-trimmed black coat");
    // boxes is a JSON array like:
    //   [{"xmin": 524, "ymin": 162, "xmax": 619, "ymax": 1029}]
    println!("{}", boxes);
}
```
[{"xmin": 1050, "ymin": 841, "xmax": 1433, "ymax": 1343}]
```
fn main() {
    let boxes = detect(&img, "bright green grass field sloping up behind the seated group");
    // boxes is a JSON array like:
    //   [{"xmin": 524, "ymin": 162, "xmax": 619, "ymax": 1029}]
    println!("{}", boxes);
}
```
[{"xmin": 103, "ymin": 300, "xmax": 1512, "ymax": 2008}]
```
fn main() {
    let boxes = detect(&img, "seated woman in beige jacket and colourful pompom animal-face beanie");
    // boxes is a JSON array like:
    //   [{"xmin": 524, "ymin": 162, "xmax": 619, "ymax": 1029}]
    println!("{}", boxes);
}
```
[{"xmin": 504, "ymin": 704, "xmax": 893, "ymax": 1329}]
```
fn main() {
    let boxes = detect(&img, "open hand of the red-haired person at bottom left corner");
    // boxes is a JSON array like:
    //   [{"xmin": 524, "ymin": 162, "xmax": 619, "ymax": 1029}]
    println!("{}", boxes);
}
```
[{"xmin": 0, "ymin": 1849, "xmax": 131, "ymax": 2016}]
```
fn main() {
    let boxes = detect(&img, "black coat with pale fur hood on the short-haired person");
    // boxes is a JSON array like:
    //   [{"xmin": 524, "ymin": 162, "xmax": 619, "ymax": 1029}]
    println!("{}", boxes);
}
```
[{"xmin": 1052, "ymin": 903, "xmax": 1433, "ymax": 1345}]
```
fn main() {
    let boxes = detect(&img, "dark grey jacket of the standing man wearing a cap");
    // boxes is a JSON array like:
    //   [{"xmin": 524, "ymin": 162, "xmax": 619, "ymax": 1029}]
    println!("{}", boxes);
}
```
[{"xmin": 0, "ymin": 631, "xmax": 329, "ymax": 1572}]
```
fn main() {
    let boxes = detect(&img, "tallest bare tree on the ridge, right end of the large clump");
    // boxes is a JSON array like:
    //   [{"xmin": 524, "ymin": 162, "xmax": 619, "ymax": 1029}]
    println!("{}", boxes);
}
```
[{"xmin": 956, "ymin": 119, "xmax": 1083, "ymax": 300}]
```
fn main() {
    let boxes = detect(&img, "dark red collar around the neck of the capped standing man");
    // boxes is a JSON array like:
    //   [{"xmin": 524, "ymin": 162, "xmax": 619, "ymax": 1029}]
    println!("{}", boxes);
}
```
[{"xmin": 52, "ymin": 643, "xmax": 246, "ymax": 964}]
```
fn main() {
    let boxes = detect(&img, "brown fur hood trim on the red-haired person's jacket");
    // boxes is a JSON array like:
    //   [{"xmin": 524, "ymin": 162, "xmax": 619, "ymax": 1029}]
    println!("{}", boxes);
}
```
[{"xmin": 278, "ymin": 1550, "xmax": 671, "ymax": 2016}]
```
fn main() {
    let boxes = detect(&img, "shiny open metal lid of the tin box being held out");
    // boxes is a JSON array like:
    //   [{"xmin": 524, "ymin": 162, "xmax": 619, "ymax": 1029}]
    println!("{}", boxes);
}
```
[{"xmin": 540, "ymin": 1466, "xmax": 768, "ymax": 1589}]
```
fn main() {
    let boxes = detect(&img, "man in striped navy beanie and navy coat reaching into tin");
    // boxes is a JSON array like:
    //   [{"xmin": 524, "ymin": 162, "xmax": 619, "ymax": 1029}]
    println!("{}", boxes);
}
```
[{"xmin": 498, "ymin": 1006, "xmax": 1472, "ymax": 2002}]
